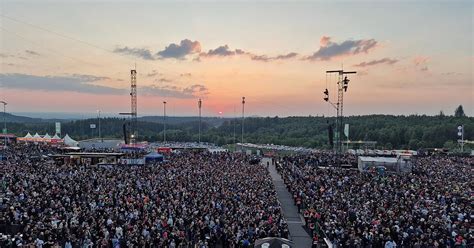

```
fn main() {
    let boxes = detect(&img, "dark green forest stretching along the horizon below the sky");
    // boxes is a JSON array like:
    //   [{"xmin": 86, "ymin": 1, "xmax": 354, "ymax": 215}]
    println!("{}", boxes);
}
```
[{"xmin": 2, "ymin": 110, "xmax": 474, "ymax": 149}]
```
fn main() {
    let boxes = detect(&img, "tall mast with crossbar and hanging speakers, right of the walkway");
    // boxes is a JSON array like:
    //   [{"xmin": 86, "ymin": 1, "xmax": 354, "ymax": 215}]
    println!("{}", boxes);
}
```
[{"xmin": 323, "ymin": 70, "xmax": 357, "ymax": 166}]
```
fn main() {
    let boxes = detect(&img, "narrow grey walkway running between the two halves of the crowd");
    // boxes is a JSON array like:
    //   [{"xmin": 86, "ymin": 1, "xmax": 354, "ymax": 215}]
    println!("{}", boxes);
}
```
[{"xmin": 269, "ymin": 164, "xmax": 312, "ymax": 248}]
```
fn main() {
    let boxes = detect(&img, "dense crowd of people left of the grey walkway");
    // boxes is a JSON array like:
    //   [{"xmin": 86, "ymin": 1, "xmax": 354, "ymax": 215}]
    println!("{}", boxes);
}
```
[{"xmin": 0, "ymin": 144, "xmax": 288, "ymax": 248}]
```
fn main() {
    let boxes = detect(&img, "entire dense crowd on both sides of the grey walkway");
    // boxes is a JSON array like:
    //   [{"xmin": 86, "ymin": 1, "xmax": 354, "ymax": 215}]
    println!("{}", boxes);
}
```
[{"xmin": 0, "ymin": 141, "xmax": 474, "ymax": 248}]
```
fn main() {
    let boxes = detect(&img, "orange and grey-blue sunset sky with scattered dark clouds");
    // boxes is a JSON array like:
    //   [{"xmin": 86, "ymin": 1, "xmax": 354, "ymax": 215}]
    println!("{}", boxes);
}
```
[{"xmin": 0, "ymin": 0, "xmax": 474, "ymax": 116}]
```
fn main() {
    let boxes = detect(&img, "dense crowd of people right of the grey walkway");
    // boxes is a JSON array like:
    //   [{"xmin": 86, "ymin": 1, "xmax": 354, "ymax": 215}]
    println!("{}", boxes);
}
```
[{"xmin": 277, "ymin": 156, "xmax": 474, "ymax": 248}]
